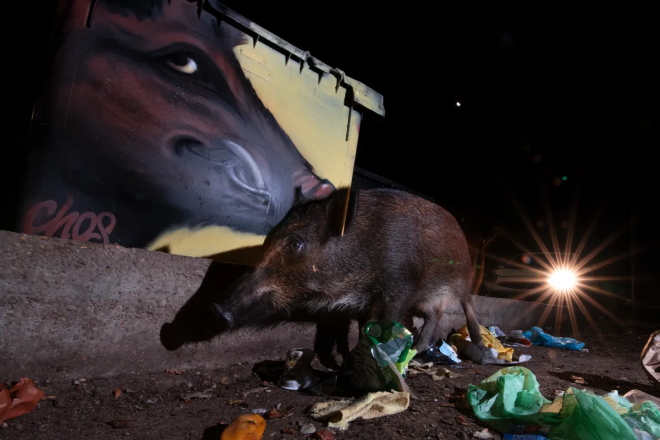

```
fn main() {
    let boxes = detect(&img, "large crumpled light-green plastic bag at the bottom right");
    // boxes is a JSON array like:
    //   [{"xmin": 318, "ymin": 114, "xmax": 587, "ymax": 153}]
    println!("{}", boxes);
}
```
[{"xmin": 467, "ymin": 367, "xmax": 640, "ymax": 440}]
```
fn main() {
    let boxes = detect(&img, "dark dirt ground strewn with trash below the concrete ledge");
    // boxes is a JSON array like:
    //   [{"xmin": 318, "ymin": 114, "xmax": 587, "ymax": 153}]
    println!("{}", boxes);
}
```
[{"xmin": 0, "ymin": 331, "xmax": 658, "ymax": 440}]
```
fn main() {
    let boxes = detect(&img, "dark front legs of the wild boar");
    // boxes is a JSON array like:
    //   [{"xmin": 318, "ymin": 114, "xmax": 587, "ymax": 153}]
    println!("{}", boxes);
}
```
[{"xmin": 314, "ymin": 314, "xmax": 351, "ymax": 370}]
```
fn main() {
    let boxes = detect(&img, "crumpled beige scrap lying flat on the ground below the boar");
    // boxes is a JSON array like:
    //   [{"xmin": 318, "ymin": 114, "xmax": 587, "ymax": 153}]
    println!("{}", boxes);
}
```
[{"xmin": 309, "ymin": 391, "xmax": 410, "ymax": 430}]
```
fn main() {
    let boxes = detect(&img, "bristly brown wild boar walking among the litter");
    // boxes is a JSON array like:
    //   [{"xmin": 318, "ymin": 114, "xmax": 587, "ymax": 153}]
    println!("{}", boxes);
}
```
[{"xmin": 212, "ymin": 189, "xmax": 482, "ymax": 365}]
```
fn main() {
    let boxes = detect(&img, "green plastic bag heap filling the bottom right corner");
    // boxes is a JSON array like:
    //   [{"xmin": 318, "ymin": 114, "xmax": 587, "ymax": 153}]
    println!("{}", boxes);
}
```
[{"xmin": 468, "ymin": 367, "xmax": 660, "ymax": 440}]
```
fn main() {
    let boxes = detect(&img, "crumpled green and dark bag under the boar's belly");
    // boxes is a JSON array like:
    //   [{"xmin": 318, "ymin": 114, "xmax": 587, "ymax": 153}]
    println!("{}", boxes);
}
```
[{"xmin": 344, "ymin": 320, "xmax": 417, "ymax": 392}]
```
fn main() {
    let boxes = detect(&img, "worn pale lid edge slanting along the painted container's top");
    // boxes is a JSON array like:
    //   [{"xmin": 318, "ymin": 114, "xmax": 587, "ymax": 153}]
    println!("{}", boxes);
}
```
[{"xmin": 204, "ymin": 0, "xmax": 385, "ymax": 117}]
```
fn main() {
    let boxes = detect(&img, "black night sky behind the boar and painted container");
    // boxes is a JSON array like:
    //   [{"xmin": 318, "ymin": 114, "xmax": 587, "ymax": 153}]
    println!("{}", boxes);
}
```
[{"xmin": 6, "ymin": 0, "xmax": 660, "ymax": 322}]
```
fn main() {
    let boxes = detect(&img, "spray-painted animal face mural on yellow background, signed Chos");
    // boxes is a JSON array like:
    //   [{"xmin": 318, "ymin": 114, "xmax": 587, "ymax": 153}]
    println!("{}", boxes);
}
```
[{"xmin": 20, "ymin": 0, "xmax": 384, "ymax": 262}]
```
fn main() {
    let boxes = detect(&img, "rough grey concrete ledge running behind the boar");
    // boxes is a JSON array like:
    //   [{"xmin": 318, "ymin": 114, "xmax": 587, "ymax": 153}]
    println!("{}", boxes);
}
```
[{"xmin": 0, "ymin": 231, "xmax": 566, "ymax": 379}]
